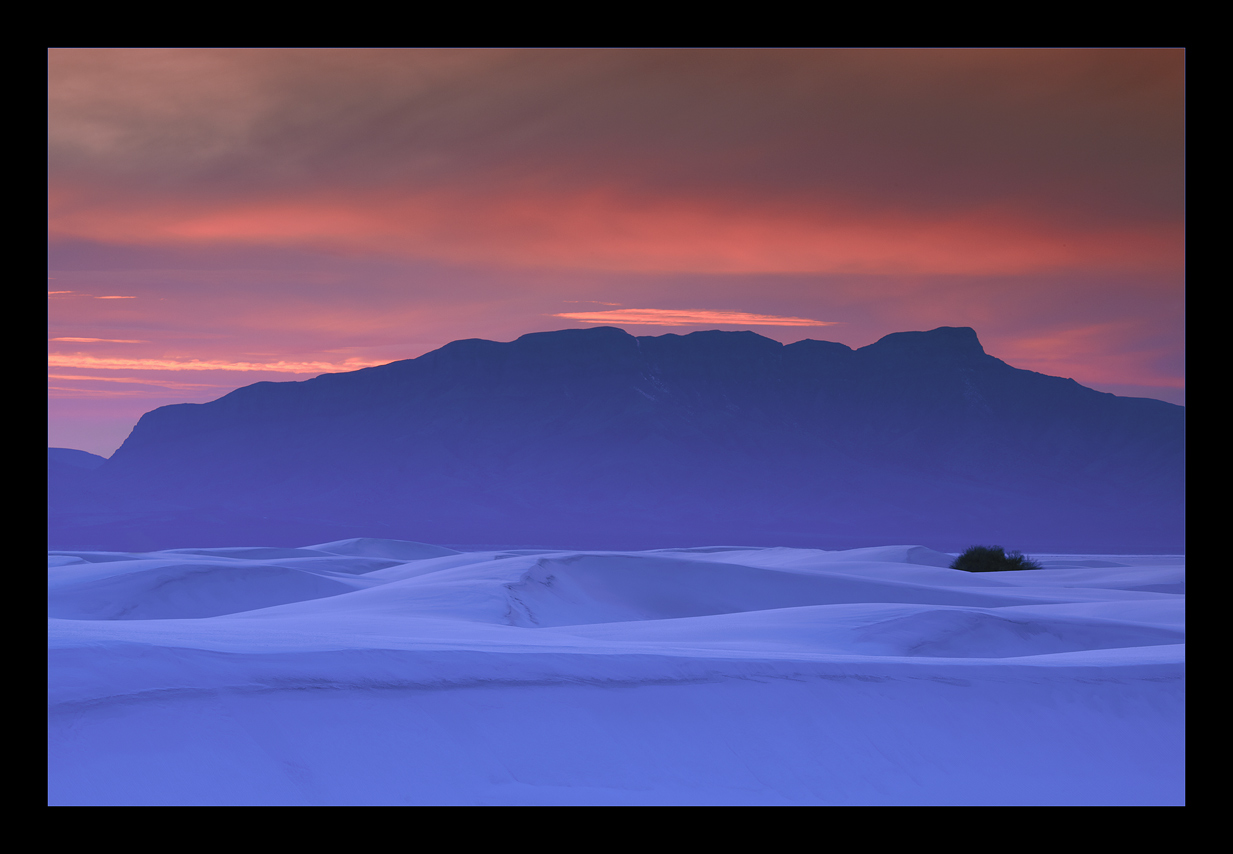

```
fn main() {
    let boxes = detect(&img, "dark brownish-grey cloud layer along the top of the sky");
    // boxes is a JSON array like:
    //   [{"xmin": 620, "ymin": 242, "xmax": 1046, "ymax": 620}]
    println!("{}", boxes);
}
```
[{"xmin": 52, "ymin": 49, "xmax": 1184, "ymax": 221}]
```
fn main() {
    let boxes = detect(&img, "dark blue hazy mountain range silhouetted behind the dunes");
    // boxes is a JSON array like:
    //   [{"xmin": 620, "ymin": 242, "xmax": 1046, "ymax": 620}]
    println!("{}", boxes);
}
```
[{"xmin": 49, "ymin": 327, "xmax": 1185, "ymax": 552}]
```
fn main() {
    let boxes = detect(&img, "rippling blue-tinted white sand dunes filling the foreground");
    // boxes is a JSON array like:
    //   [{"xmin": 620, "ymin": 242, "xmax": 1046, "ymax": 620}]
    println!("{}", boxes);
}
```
[{"xmin": 48, "ymin": 539, "xmax": 1185, "ymax": 806}]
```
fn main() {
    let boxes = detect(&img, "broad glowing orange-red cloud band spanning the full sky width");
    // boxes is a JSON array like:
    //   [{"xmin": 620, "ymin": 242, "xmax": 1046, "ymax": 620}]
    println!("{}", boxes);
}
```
[{"xmin": 51, "ymin": 191, "xmax": 1184, "ymax": 275}]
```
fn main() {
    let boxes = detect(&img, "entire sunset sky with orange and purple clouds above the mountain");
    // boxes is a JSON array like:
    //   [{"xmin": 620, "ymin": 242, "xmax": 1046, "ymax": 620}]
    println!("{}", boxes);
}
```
[{"xmin": 47, "ymin": 48, "xmax": 1185, "ymax": 456}]
